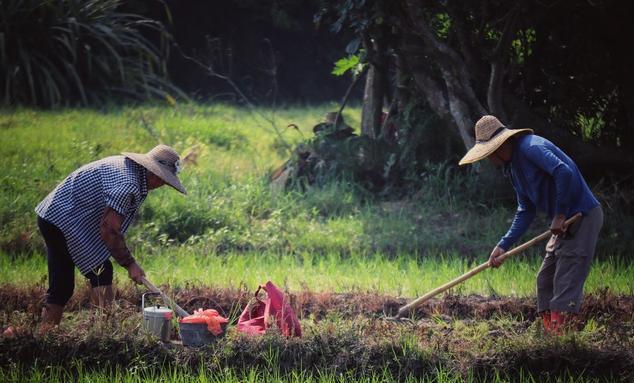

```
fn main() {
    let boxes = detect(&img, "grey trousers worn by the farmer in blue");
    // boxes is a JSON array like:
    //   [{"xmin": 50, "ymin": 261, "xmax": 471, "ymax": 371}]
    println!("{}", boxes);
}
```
[{"xmin": 537, "ymin": 206, "xmax": 603, "ymax": 313}]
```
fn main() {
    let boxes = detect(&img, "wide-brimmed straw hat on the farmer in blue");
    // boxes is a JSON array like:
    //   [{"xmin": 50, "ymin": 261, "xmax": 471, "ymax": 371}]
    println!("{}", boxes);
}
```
[{"xmin": 460, "ymin": 116, "xmax": 533, "ymax": 165}]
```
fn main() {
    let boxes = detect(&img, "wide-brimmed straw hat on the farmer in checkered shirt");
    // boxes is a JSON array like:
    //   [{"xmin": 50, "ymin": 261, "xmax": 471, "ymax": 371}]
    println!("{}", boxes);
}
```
[{"xmin": 121, "ymin": 144, "xmax": 187, "ymax": 194}]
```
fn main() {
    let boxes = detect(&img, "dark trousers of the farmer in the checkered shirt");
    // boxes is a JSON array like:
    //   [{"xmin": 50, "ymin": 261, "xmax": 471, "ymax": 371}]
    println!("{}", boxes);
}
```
[{"xmin": 37, "ymin": 217, "xmax": 112, "ymax": 306}]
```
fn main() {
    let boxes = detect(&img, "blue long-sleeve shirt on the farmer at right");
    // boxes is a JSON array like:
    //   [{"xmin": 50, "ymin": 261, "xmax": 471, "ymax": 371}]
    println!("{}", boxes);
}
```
[{"xmin": 498, "ymin": 134, "xmax": 599, "ymax": 250}]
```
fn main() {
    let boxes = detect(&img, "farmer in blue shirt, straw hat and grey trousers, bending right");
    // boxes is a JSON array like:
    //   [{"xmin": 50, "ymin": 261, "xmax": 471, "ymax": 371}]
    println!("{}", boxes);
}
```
[{"xmin": 460, "ymin": 116, "xmax": 603, "ymax": 333}]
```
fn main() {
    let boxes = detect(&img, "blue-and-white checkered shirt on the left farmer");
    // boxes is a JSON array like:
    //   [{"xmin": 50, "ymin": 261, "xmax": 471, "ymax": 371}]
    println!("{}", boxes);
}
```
[{"xmin": 35, "ymin": 156, "xmax": 147, "ymax": 275}]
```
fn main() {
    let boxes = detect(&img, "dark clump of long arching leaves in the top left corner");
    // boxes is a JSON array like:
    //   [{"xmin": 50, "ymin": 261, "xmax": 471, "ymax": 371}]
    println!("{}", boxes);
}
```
[{"xmin": 0, "ymin": 0, "xmax": 181, "ymax": 107}]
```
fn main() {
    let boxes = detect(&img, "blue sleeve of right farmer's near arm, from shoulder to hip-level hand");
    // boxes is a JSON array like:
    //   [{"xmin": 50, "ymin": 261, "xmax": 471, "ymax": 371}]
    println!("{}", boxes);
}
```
[{"xmin": 526, "ymin": 145, "xmax": 573, "ymax": 215}]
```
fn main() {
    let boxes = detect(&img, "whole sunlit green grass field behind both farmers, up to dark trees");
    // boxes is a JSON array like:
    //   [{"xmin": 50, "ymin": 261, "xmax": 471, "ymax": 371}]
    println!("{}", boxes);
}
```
[{"xmin": 0, "ymin": 105, "xmax": 634, "ymax": 297}]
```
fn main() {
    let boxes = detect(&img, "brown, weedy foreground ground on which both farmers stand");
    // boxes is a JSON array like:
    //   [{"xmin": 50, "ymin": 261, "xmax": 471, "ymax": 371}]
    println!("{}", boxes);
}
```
[{"xmin": 0, "ymin": 285, "xmax": 634, "ymax": 381}]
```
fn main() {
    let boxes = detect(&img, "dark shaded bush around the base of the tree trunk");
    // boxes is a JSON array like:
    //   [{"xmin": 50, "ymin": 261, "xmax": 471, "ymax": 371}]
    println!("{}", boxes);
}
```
[{"xmin": 278, "ymin": 101, "xmax": 476, "ymax": 201}]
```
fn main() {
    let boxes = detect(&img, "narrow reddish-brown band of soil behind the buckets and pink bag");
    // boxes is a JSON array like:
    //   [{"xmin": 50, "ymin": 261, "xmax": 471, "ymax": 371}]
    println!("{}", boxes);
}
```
[{"xmin": 0, "ymin": 285, "xmax": 634, "ymax": 322}]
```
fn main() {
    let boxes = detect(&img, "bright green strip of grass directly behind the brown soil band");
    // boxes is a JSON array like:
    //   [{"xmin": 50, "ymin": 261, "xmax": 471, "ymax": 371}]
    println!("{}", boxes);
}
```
[{"xmin": 0, "ymin": 247, "xmax": 634, "ymax": 298}]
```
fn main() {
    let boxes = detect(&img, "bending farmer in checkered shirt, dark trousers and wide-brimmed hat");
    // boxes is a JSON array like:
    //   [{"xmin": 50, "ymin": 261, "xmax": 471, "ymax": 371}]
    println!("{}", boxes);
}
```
[{"xmin": 35, "ymin": 145, "xmax": 186, "ymax": 333}]
